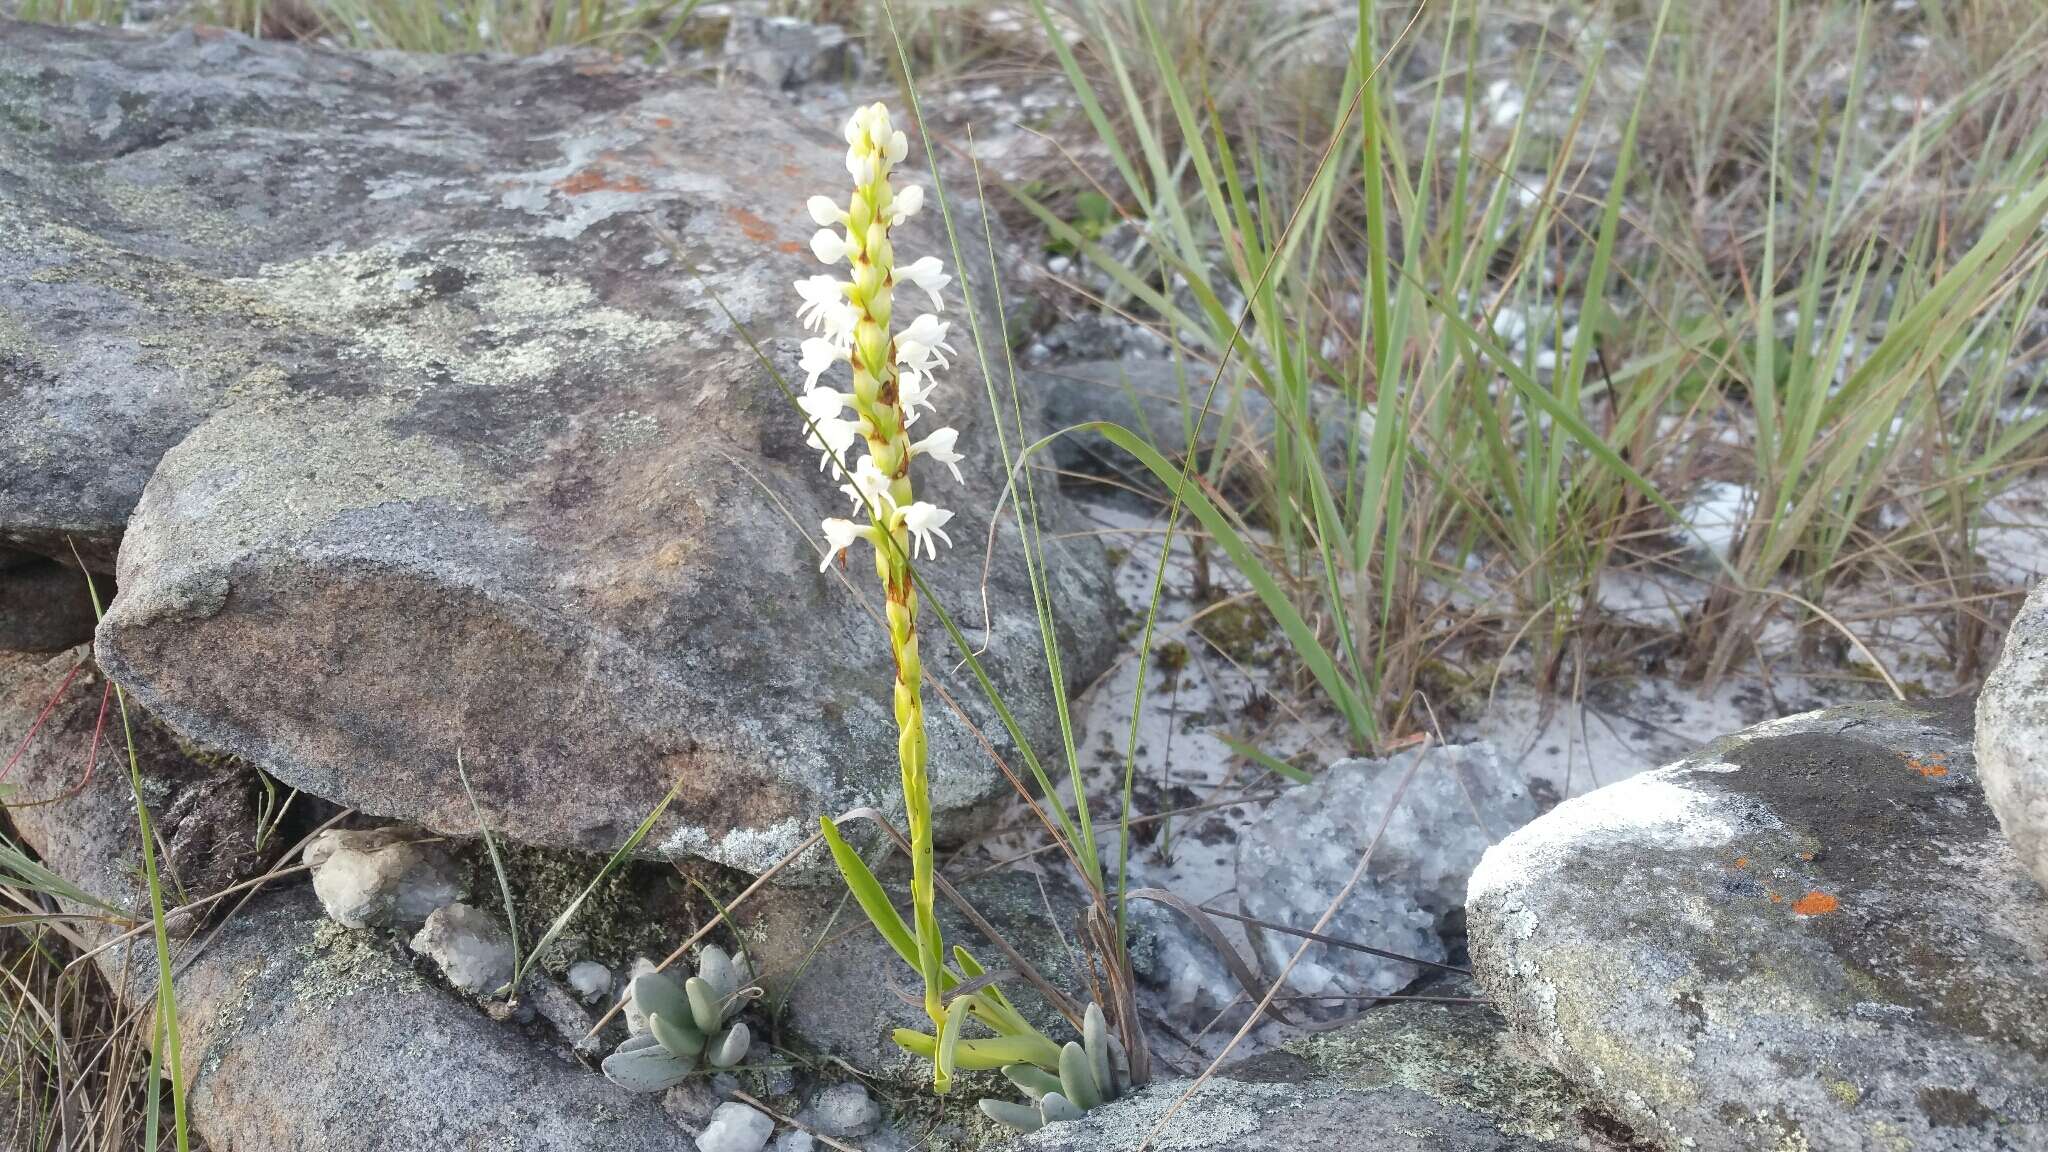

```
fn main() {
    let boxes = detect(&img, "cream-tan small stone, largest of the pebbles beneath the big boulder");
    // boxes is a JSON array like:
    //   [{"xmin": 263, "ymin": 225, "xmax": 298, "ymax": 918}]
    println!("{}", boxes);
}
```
[{"xmin": 305, "ymin": 824, "xmax": 463, "ymax": 929}]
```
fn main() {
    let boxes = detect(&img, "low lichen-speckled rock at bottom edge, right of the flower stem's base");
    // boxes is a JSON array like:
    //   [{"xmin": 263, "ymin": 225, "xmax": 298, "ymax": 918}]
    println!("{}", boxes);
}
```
[{"xmin": 985, "ymin": 984, "xmax": 1630, "ymax": 1152}]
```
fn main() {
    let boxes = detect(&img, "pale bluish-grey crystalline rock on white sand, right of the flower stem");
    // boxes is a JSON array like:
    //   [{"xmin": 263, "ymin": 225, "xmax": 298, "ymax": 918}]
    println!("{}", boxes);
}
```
[{"xmin": 1237, "ymin": 744, "xmax": 1536, "ymax": 1015}]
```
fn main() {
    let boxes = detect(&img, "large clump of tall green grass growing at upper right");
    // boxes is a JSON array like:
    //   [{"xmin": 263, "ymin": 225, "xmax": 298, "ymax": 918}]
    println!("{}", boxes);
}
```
[{"xmin": 1014, "ymin": 0, "xmax": 2048, "ymax": 746}]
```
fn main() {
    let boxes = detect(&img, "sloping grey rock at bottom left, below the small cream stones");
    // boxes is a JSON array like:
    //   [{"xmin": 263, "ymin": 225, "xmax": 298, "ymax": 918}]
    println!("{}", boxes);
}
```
[{"xmin": 163, "ymin": 886, "xmax": 684, "ymax": 1152}]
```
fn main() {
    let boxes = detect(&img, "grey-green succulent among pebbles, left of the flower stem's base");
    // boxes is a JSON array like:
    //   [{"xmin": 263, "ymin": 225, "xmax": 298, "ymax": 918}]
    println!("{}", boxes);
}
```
[{"xmin": 604, "ymin": 945, "xmax": 756, "ymax": 1093}]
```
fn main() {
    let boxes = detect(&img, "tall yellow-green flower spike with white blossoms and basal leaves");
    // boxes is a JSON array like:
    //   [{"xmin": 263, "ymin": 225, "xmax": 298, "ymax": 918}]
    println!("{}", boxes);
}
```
[{"xmin": 797, "ymin": 105, "xmax": 1089, "ymax": 1093}]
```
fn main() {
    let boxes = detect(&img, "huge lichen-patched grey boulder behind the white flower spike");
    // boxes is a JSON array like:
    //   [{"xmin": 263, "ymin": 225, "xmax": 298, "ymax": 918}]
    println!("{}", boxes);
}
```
[{"xmin": 0, "ymin": 23, "xmax": 1114, "ymax": 871}]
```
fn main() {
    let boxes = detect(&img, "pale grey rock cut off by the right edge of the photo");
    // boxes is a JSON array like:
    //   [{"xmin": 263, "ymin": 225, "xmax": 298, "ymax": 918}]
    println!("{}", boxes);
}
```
[{"xmin": 1976, "ymin": 584, "xmax": 2048, "ymax": 888}]
